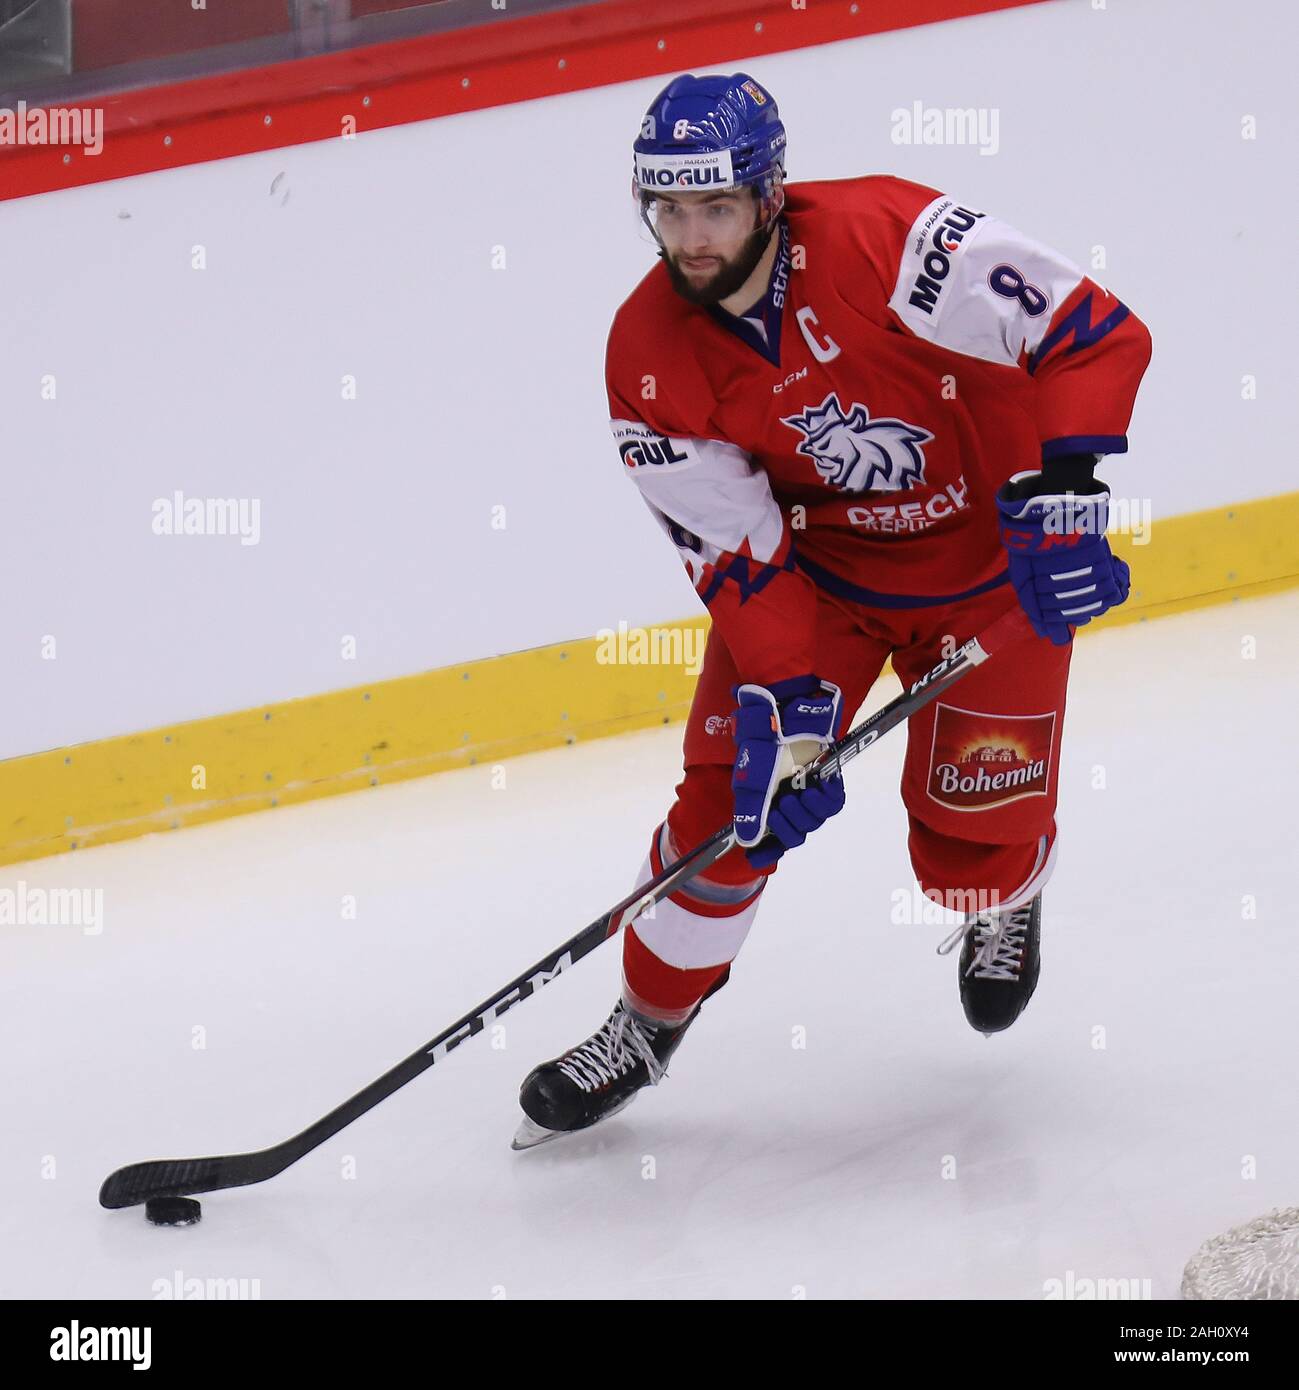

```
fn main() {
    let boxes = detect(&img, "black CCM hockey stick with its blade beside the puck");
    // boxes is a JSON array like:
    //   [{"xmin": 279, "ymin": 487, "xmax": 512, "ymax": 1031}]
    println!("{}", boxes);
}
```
[{"xmin": 99, "ymin": 606, "xmax": 1031, "ymax": 1208}]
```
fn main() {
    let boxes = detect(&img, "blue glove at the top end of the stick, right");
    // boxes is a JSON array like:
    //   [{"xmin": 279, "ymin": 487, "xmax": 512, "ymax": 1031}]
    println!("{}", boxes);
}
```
[{"xmin": 996, "ymin": 473, "xmax": 1128, "ymax": 646}]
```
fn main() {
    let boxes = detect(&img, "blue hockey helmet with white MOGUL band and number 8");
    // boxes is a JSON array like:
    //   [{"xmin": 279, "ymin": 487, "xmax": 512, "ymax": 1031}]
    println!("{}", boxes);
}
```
[{"xmin": 632, "ymin": 72, "xmax": 785, "ymax": 240}]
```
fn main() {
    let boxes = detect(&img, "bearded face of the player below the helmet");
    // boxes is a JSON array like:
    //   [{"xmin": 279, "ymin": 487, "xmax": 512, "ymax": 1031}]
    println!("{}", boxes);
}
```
[{"xmin": 654, "ymin": 188, "xmax": 767, "ymax": 304}]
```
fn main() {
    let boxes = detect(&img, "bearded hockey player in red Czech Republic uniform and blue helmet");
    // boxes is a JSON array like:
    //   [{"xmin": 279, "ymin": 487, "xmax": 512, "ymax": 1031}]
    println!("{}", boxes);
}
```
[{"xmin": 515, "ymin": 72, "xmax": 1150, "ymax": 1148}]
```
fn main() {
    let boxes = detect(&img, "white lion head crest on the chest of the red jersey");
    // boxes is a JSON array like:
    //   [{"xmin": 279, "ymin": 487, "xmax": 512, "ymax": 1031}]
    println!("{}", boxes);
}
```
[{"xmin": 781, "ymin": 391, "xmax": 934, "ymax": 492}]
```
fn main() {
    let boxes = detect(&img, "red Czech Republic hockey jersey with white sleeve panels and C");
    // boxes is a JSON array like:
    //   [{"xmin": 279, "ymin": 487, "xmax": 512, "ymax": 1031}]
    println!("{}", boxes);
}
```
[{"xmin": 606, "ymin": 175, "xmax": 1150, "ymax": 684}]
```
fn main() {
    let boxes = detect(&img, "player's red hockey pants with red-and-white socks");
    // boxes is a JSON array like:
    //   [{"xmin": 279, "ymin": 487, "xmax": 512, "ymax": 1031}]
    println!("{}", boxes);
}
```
[{"xmin": 622, "ymin": 585, "xmax": 1073, "ymax": 1022}]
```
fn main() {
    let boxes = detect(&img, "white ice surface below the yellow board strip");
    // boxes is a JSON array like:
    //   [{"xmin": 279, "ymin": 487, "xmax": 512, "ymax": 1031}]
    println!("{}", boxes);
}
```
[{"xmin": 0, "ymin": 592, "xmax": 1299, "ymax": 1300}]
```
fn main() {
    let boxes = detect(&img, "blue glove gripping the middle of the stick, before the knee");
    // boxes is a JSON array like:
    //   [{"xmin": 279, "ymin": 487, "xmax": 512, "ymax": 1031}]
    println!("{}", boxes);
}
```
[{"xmin": 731, "ymin": 676, "xmax": 843, "ymax": 869}]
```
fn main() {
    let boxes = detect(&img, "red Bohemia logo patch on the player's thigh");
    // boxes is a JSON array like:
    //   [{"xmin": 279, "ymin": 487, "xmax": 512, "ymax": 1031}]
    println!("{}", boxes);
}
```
[{"xmin": 925, "ymin": 703, "xmax": 1056, "ymax": 810}]
